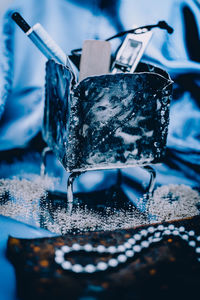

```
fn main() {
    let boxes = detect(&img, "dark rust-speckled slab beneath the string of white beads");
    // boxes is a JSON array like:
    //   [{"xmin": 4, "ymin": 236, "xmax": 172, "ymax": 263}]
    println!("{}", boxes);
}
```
[{"xmin": 8, "ymin": 217, "xmax": 200, "ymax": 300}]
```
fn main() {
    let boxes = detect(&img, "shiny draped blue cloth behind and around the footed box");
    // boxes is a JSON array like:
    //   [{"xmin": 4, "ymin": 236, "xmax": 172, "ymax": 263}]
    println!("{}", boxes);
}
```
[{"xmin": 0, "ymin": 0, "xmax": 200, "ymax": 300}]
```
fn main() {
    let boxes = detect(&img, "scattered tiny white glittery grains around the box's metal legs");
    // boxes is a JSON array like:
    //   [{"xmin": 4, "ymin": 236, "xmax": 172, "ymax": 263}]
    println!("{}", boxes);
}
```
[{"xmin": 0, "ymin": 176, "xmax": 200, "ymax": 234}]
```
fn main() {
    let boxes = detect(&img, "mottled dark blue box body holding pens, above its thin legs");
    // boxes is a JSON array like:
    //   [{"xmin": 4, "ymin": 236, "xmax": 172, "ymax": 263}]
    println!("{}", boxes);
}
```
[{"xmin": 43, "ymin": 61, "xmax": 172, "ymax": 171}]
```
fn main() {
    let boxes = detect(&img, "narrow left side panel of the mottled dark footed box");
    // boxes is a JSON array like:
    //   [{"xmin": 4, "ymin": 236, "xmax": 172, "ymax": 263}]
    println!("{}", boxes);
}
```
[{"xmin": 43, "ymin": 61, "xmax": 73, "ymax": 161}]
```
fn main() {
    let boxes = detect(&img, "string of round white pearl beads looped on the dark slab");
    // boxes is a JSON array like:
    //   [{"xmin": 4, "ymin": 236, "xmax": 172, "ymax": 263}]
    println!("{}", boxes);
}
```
[{"xmin": 55, "ymin": 224, "xmax": 200, "ymax": 274}]
